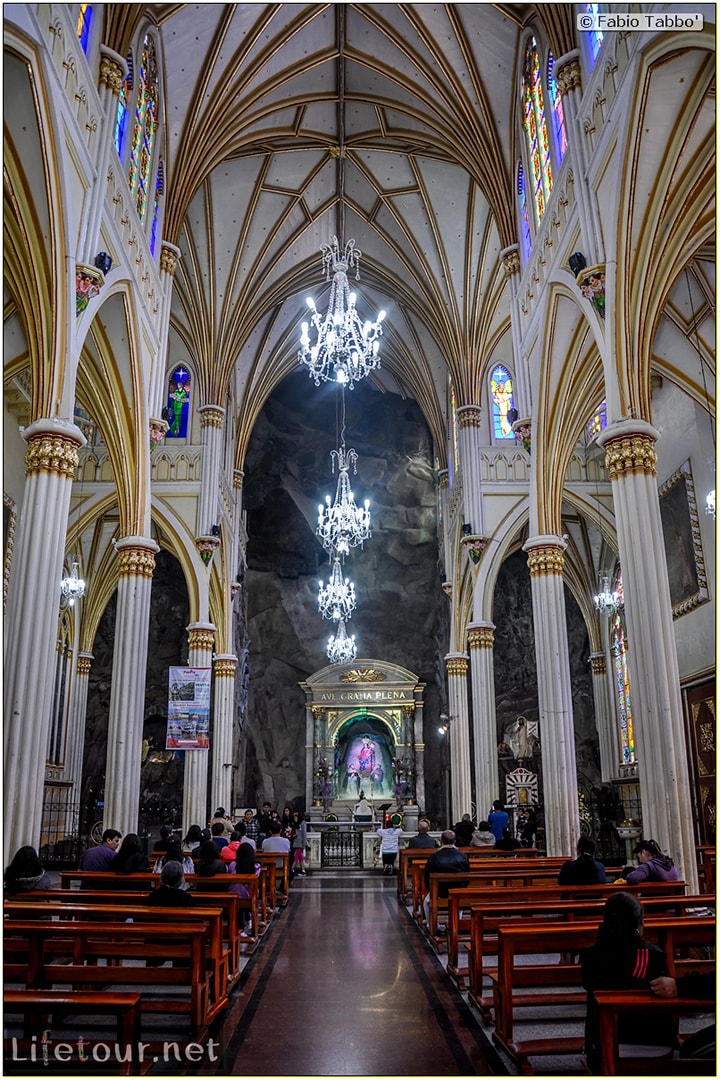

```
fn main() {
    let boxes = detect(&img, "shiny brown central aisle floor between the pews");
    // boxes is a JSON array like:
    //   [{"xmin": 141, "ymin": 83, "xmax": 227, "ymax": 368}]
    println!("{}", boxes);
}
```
[{"xmin": 191, "ymin": 872, "xmax": 506, "ymax": 1077}]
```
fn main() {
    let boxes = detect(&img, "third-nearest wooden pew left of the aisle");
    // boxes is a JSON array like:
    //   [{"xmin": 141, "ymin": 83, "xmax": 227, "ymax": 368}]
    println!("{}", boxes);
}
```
[{"xmin": 3, "ymin": 899, "xmax": 231, "ymax": 1002}]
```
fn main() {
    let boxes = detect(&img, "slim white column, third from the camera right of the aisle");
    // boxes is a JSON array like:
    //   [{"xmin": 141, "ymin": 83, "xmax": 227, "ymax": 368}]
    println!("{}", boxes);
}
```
[{"xmin": 467, "ymin": 622, "xmax": 501, "ymax": 819}]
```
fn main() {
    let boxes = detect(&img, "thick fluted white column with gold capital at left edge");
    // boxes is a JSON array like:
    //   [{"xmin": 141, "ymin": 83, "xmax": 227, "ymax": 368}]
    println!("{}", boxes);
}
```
[{"xmin": 4, "ymin": 419, "xmax": 85, "ymax": 861}]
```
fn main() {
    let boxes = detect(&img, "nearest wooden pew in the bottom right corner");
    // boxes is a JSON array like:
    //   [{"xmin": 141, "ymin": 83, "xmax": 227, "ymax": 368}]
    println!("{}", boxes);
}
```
[{"xmin": 594, "ymin": 990, "xmax": 717, "ymax": 1077}]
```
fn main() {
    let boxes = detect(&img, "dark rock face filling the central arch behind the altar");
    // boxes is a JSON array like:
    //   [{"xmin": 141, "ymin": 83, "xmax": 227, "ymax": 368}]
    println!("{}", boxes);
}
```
[{"xmin": 241, "ymin": 373, "xmax": 447, "ymax": 806}]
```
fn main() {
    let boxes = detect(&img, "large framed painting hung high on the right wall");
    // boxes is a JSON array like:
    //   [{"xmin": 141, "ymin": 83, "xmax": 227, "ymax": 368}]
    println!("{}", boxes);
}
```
[{"xmin": 658, "ymin": 461, "xmax": 708, "ymax": 619}]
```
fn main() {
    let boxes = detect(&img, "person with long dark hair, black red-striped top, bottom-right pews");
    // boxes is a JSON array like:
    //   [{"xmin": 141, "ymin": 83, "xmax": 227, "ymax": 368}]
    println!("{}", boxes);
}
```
[{"xmin": 581, "ymin": 892, "xmax": 674, "ymax": 1071}]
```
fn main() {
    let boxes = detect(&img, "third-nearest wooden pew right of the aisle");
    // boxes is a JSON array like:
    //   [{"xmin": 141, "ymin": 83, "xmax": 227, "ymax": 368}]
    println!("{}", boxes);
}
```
[{"xmin": 464, "ymin": 881, "xmax": 712, "ymax": 1010}]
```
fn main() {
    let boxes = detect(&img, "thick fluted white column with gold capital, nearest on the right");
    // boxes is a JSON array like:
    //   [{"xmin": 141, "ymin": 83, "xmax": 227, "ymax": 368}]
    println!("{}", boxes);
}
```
[{"xmin": 598, "ymin": 420, "xmax": 697, "ymax": 892}]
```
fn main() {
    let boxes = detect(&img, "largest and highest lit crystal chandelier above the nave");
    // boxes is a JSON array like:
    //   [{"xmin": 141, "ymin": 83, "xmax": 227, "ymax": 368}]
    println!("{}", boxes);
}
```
[{"xmin": 298, "ymin": 237, "xmax": 385, "ymax": 390}]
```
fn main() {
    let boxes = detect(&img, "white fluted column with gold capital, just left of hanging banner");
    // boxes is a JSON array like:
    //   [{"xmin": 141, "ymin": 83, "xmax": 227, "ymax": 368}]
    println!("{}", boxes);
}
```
[{"xmin": 103, "ymin": 537, "xmax": 159, "ymax": 833}]
